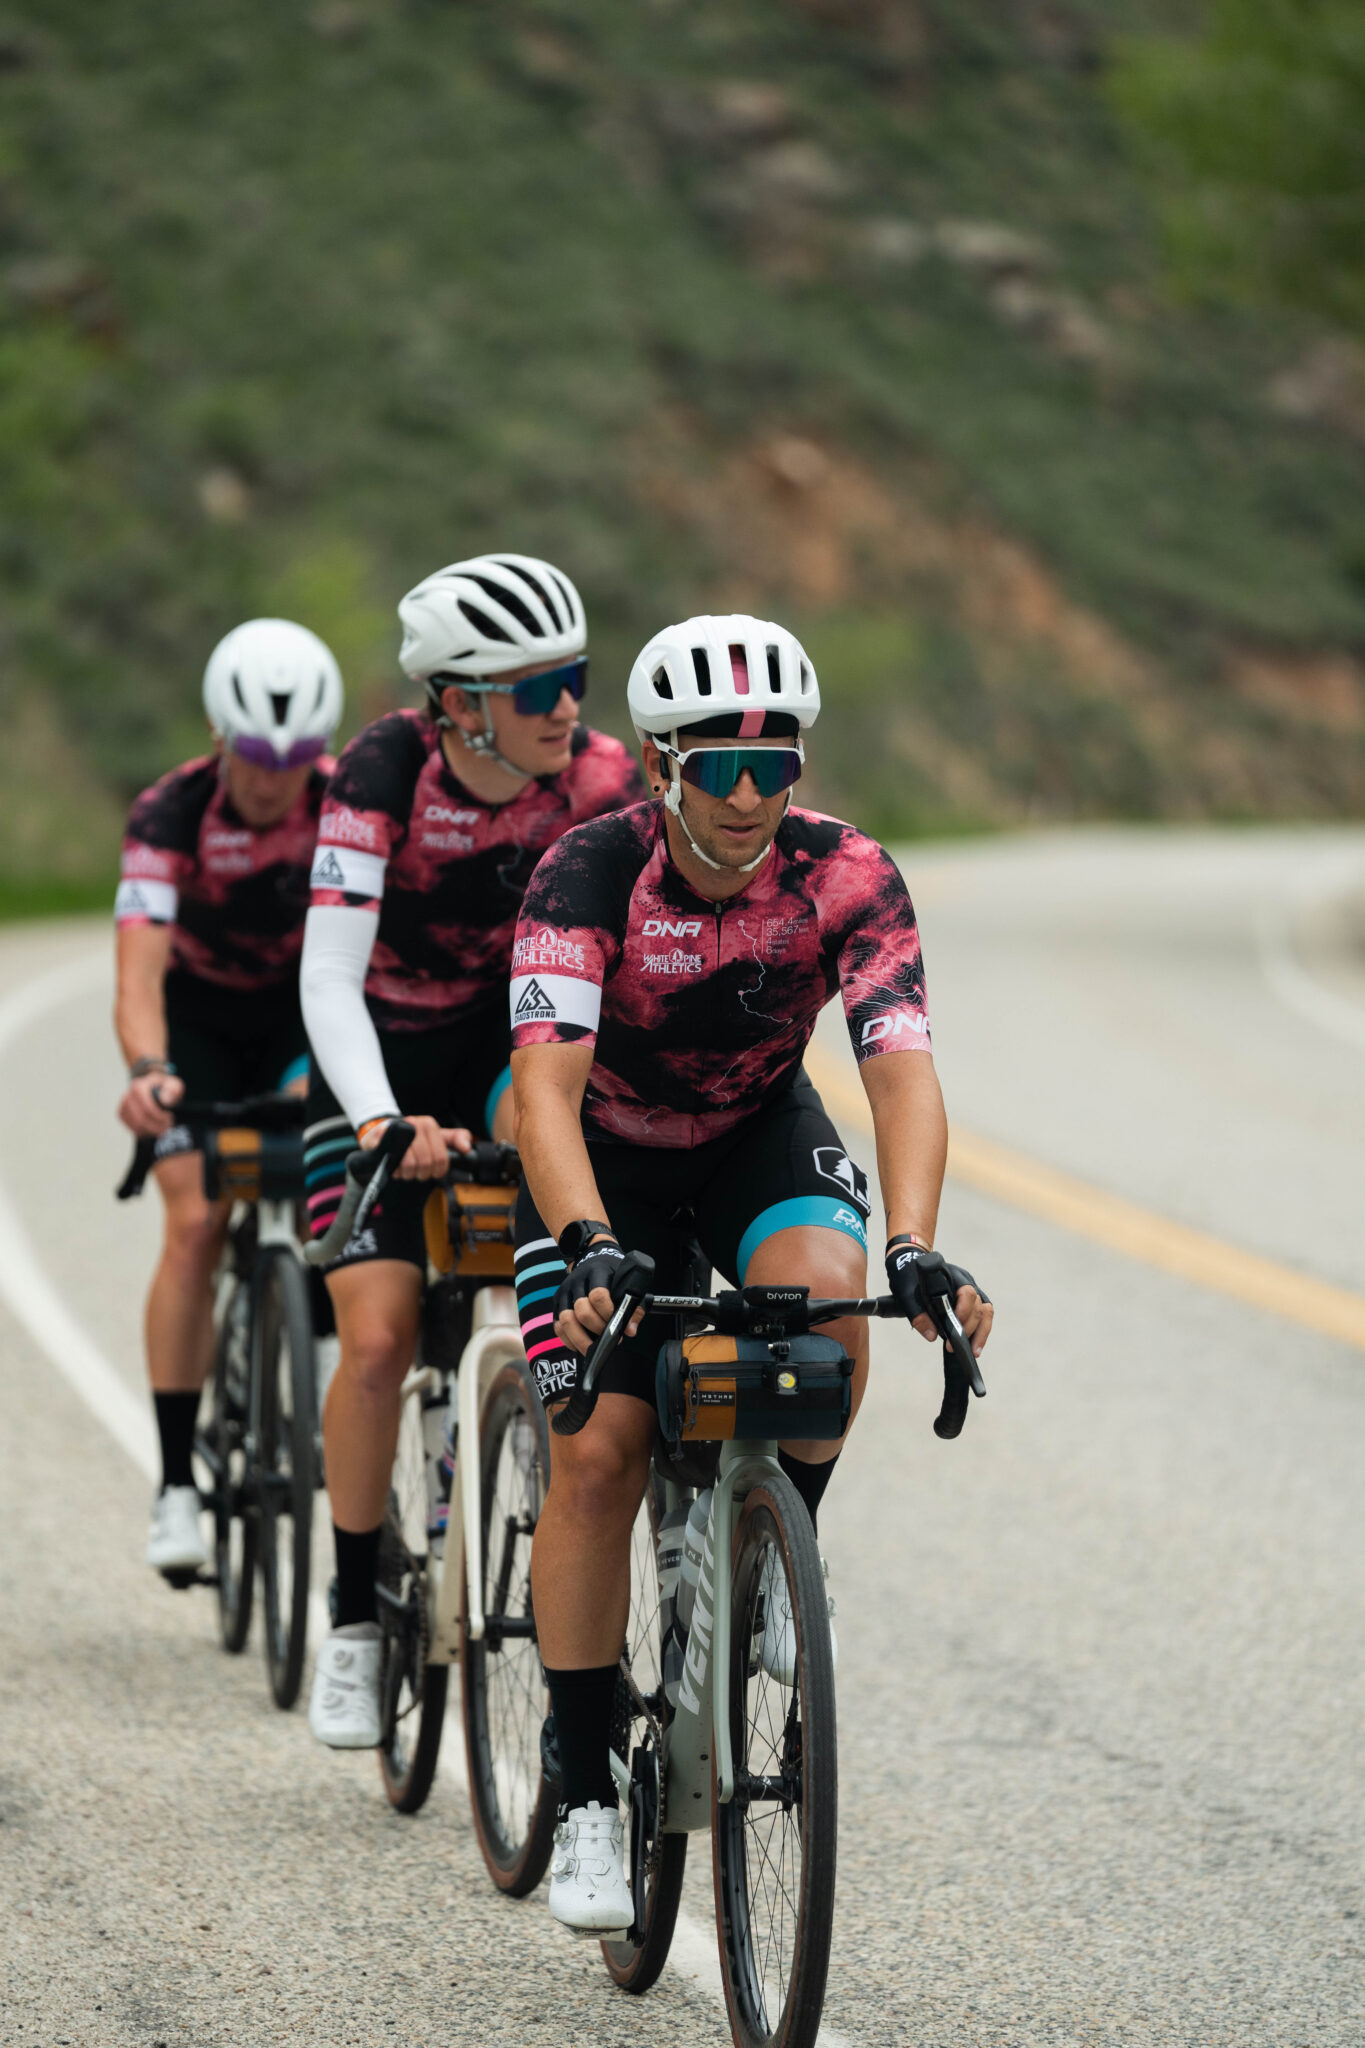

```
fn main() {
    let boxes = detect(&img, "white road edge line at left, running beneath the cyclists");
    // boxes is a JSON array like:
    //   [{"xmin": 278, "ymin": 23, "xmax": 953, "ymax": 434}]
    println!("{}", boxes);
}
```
[{"xmin": 0, "ymin": 952, "xmax": 851, "ymax": 2048}]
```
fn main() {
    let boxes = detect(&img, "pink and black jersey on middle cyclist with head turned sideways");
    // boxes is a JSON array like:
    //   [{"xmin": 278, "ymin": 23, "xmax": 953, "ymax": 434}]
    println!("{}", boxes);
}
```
[{"xmin": 313, "ymin": 711, "xmax": 643, "ymax": 1032}]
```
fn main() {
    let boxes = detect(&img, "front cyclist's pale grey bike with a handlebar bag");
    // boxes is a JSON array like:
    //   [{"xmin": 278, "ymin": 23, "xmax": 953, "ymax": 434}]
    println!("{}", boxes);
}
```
[{"xmin": 553, "ymin": 1253, "xmax": 986, "ymax": 2048}]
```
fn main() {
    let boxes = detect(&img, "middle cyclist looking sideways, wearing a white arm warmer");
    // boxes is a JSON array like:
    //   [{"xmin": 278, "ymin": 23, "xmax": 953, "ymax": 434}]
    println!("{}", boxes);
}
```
[{"xmin": 303, "ymin": 555, "xmax": 643, "ymax": 1749}]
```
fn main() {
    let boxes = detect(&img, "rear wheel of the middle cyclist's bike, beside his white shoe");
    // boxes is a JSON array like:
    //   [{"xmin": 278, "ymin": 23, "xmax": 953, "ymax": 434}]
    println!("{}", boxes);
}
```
[{"xmin": 379, "ymin": 1393, "xmax": 450, "ymax": 1812}]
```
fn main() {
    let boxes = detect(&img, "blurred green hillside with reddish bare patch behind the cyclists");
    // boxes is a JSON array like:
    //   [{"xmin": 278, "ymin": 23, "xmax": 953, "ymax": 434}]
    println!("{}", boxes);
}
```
[{"xmin": 0, "ymin": 0, "xmax": 1365, "ymax": 899}]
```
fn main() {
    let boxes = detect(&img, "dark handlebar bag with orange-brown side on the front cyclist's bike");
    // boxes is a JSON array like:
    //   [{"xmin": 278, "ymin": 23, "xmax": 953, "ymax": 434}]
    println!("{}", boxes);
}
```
[{"xmin": 655, "ymin": 1331, "xmax": 853, "ymax": 1444}]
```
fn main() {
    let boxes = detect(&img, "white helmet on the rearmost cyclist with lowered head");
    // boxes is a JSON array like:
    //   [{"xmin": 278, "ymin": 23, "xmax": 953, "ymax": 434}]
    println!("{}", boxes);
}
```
[{"xmin": 205, "ymin": 618, "xmax": 346, "ymax": 768}]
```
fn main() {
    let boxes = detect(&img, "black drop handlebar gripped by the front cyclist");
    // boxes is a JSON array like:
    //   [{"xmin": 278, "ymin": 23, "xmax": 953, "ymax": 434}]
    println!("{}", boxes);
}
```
[{"xmin": 551, "ymin": 1251, "xmax": 986, "ymax": 1438}]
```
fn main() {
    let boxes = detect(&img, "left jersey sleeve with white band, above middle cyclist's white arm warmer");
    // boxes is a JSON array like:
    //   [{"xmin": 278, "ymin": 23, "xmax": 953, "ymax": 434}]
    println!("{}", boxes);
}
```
[{"xmin": 309, "ymin": 713, "xmax": 426, "ymax": 911}]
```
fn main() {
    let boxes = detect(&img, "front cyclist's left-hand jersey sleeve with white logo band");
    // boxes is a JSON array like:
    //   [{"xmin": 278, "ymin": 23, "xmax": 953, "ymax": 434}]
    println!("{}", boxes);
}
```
[{"xmin": 510, "ymin": 829, "xmax": 620, "ymax": 1051}]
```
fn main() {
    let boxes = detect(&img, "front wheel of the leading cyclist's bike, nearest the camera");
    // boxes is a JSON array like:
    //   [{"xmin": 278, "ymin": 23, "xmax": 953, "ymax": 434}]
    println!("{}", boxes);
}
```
[{"xmin": 712, "ymin": 1473, "xmax": 839, "ymax": 2048}]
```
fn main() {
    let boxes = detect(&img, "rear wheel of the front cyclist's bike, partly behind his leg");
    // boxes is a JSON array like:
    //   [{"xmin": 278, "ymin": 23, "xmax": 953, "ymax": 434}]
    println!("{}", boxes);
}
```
[{"xmin": 602, "ymin": 1473, "xmax": 688, "ymax": 1995}]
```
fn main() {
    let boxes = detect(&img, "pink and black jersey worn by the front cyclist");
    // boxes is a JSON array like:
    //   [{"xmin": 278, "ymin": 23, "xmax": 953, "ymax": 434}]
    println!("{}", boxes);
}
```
[{"xmin": 512, "ymin": 803, "xmax": 929, "ymax": 1147}]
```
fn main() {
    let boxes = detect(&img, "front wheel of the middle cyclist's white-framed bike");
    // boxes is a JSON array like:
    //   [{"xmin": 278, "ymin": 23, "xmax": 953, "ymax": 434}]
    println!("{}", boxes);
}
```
[{"xmin": 460, "ymin": 1360, "xmax": 555, "ymax": 1898}]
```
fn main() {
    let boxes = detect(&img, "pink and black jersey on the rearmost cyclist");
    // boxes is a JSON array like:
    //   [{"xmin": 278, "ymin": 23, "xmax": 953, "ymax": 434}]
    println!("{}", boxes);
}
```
[{"xmin": 115, "ymin": 754, "xmax": 332, "ymax": 991}]
